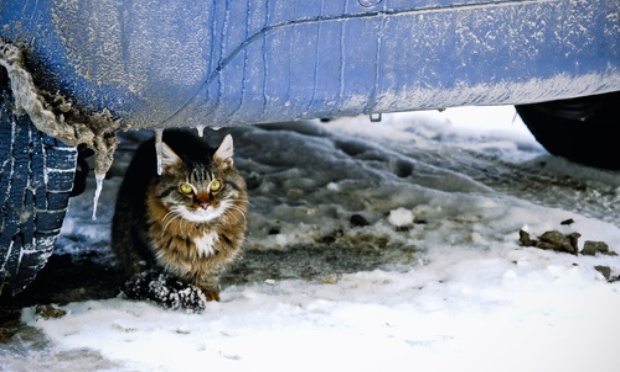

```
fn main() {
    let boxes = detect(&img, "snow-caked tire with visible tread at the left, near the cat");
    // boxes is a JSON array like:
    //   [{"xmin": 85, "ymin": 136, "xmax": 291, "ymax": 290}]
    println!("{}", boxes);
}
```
[{"xmin": 0, "ymin": 68, "xmax": 77, "ymax": 297}]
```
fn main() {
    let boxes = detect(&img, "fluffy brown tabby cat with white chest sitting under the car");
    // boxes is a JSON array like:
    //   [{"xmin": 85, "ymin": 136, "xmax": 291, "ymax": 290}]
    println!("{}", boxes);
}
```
[{"xmin": 112, "ymin": 130, "xmax": 248, "ymax": 301}]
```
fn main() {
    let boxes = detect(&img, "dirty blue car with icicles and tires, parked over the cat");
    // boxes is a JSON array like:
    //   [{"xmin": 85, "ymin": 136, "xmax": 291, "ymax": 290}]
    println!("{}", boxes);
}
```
[{"xmin": 0, "ymin": 0, "xmax": 620, "ymax": 296}]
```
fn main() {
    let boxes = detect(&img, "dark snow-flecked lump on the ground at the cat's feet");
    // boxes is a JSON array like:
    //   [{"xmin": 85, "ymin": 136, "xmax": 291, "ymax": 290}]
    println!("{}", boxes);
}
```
[{"xmin": 122, "ymin": 270, "xmax": 208, "ymax": 313}]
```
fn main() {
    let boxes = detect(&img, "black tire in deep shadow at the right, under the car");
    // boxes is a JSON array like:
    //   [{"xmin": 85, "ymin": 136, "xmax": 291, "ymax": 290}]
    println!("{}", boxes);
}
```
[{"xmin": 516, "ymin": 92, "xmax": 620, "ymax": 170}]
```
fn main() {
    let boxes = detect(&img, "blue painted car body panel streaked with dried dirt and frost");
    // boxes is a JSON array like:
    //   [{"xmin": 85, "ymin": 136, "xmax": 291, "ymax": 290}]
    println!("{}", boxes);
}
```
[{"xmin": 0, "ymin": 0, "xmax": 620, "ymax": 127}]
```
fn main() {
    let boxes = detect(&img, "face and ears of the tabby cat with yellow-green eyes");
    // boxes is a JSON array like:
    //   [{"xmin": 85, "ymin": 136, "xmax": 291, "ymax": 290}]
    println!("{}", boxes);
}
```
[{"xmin": 155, "ymin": 135, "xmax": 245, "ymax": 223}]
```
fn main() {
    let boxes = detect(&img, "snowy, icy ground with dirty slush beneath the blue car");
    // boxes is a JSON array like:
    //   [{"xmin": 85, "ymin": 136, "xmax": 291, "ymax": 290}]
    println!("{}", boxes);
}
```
[{"xmin": 0, "ymin": 108, "xmax": 620, "ymax": 372}]
